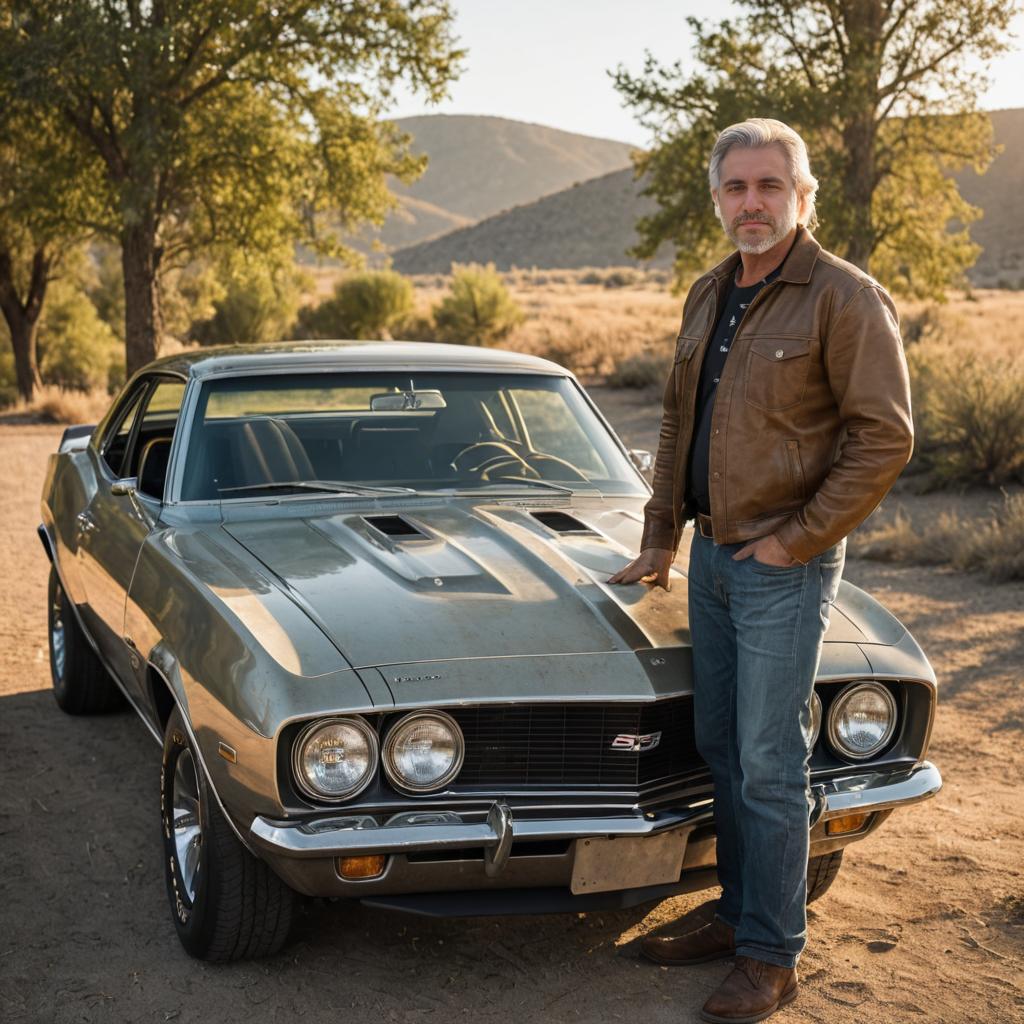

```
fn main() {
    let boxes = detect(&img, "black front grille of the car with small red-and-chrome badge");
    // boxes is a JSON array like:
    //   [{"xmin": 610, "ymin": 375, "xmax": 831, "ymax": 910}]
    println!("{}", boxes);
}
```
[{"xmin": 449, "ymin": 696, "xmax": 703, "ymax": 787}]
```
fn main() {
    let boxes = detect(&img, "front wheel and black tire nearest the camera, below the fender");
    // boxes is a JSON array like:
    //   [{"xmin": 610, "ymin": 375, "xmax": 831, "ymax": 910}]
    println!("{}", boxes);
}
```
[{"xmin": 160, "ymin": 709, "xmax": 295, "ymax": 961}]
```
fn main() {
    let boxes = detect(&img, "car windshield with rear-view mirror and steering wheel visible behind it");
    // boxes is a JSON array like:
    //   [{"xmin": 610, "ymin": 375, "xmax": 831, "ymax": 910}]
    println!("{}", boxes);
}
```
[{"xmin": 175, "ymin": 371, "xmax": 642, "ymax": 501}]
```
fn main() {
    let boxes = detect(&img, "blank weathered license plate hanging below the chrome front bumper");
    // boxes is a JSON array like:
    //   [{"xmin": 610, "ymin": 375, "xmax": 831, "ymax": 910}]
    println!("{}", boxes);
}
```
[{"xmin": 570, "ymin": 828, "xmax": 688, "ymax": 896}]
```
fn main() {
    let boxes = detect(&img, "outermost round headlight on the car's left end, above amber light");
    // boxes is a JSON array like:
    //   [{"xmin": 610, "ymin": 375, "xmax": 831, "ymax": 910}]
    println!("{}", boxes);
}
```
[{"xmin": 292, "ymin": 718, "xmax": 378, "ymax": 800}]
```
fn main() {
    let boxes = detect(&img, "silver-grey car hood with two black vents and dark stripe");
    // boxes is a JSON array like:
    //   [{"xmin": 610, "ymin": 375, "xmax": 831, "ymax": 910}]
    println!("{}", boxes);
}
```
[{"xmin": 222, "ymin": 500, "xmax": 888, "ymax": 669}]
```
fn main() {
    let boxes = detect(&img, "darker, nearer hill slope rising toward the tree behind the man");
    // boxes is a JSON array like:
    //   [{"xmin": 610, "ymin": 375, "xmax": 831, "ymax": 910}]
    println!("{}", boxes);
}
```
[{"xmin": 394, "ymin": 168, "xmax": 671, "ymax": 273}]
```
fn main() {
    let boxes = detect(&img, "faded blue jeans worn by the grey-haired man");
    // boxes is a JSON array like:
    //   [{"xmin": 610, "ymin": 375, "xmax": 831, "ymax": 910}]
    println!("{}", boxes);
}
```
[{"xmin": 688, "ymin": 530, "xmax": 846, "ymax": 967}]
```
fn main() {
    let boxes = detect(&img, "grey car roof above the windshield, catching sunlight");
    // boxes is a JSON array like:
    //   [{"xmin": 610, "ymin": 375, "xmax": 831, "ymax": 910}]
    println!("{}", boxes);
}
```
[{"xmin": 143, "ymin": 341, "xmax": 568, "ymax": 378}]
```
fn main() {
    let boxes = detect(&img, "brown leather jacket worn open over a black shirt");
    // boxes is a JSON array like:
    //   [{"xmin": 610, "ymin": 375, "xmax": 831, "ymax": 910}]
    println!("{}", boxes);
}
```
[{"xmin": 642, "ymin": 227, "xmax": 913, "ymax": 563}]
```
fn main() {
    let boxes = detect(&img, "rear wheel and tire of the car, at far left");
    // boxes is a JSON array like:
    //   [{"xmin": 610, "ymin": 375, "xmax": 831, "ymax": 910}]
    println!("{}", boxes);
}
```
[{"xmin": 46, "ymin": 564, "xmax": 125, "ymax": 715}]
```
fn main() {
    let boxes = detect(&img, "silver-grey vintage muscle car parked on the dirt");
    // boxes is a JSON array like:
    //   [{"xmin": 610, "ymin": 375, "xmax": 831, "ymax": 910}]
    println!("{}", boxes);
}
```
[{"xmin": 39, "ymin": 342, "xmax": 941, "ymax": 959}]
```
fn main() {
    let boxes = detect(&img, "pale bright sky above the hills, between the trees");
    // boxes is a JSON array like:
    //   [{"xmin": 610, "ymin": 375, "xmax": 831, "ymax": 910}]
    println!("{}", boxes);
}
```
[{"xmin": 392, "ymin": 0, "xmax": 1024, "ymax": 146}]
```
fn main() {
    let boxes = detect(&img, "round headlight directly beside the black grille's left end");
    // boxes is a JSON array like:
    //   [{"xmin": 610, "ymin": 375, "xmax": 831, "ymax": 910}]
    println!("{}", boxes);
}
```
[{"xmin": 383, "ymin": 711, "xmax": 466, "ymax": 793}]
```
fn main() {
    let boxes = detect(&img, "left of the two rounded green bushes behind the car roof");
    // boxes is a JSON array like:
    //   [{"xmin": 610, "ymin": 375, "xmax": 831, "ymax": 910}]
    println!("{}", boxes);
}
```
[{"xmin": 298, "ymin": 270, "xmax": 413, "ymax": 338}]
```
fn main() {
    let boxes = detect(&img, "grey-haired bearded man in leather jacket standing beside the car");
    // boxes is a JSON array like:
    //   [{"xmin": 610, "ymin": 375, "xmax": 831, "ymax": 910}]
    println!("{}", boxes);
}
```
[{"xmin": 609, "ymin": 118, "xmax": 913, "ymax": 1022}]
